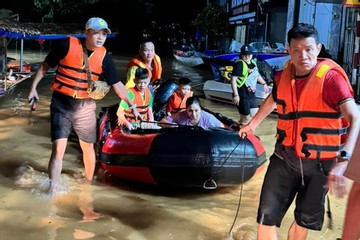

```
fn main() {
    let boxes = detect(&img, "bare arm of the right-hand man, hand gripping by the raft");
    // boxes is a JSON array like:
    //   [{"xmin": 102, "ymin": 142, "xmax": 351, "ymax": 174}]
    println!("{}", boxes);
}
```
[{"xmin": 239, "ymin": 93, "xmax": 276, "ymax": 138}]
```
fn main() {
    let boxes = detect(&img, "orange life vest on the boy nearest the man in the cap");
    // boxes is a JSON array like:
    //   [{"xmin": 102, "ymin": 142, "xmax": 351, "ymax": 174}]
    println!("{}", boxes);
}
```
[{"xmin": 124, "ymin": 87, "xmax": 151, "ymax": 123}]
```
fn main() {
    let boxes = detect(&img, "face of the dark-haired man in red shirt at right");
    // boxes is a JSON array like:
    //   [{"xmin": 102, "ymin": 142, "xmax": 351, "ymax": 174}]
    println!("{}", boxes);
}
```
[{"xmin": 287, "ymin": 37, "xmax": 321, "ymax": 76}]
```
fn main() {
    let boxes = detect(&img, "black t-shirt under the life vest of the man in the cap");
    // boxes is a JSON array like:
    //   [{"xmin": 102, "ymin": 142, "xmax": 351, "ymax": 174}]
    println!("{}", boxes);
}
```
[{"xmin": 45, "ymin": 38, "xmax": 120, "ymax": 86}]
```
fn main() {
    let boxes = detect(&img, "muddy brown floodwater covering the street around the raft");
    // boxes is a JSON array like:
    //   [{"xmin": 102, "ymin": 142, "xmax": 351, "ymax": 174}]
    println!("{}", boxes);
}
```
[{"xmin": 0, "ymin": 49, "xmax": 346, "ymax": 240}]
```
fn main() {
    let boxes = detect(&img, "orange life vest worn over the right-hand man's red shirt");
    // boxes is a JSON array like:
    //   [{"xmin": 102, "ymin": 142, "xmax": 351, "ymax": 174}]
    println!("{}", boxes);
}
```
[{"xmin": 276, "ymin": 59, "xmax": 352, "ymax": 160}]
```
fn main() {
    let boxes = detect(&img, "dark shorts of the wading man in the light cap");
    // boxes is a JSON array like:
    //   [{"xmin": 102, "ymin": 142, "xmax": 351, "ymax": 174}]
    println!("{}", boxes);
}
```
[{"xmin": 50, "ymin": 97, "xmax": 96, "ymax": 143}]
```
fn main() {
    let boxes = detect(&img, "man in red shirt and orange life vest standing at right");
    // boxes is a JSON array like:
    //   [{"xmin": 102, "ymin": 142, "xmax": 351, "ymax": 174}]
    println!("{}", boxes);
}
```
[{"xmin": 239, "ymin": 23, "xmax": 360, "ymax": 240}]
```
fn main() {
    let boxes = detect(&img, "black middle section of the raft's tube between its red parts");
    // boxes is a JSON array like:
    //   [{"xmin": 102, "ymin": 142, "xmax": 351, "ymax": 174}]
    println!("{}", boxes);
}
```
[{"xmin": 149, "ymin": 127, "xmax": 266, "ymax": 187}]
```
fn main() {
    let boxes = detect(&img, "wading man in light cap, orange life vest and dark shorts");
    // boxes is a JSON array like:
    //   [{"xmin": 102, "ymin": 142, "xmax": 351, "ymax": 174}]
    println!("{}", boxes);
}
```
[{"xmin": 28, "ymin": 17, "xmax": 139, "ymax": 190}]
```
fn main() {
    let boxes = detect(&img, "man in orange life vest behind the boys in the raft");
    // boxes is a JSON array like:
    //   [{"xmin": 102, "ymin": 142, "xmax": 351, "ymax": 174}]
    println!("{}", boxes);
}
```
[{"xmin": 126, "ymin": 40, "xmax": 162, "ymax": 92}]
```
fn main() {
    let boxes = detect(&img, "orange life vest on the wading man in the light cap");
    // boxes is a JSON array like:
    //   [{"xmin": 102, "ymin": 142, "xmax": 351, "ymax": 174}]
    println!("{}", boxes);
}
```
[{"xmin": 51, "ymin": 36, "xmax": 106, "ymax": 99}]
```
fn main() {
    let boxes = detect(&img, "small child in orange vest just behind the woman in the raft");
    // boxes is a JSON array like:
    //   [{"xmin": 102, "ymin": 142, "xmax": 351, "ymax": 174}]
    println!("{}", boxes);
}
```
[{"xmin": 166, "ymin": 78, "xmax": 193, "ymax": 116}]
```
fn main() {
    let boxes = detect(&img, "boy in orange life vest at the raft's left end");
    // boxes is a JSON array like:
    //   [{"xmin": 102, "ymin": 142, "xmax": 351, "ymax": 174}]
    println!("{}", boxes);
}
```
[{"xmin": 116, "ymin": 68, "xmax": 154, "ymax": 130}]
